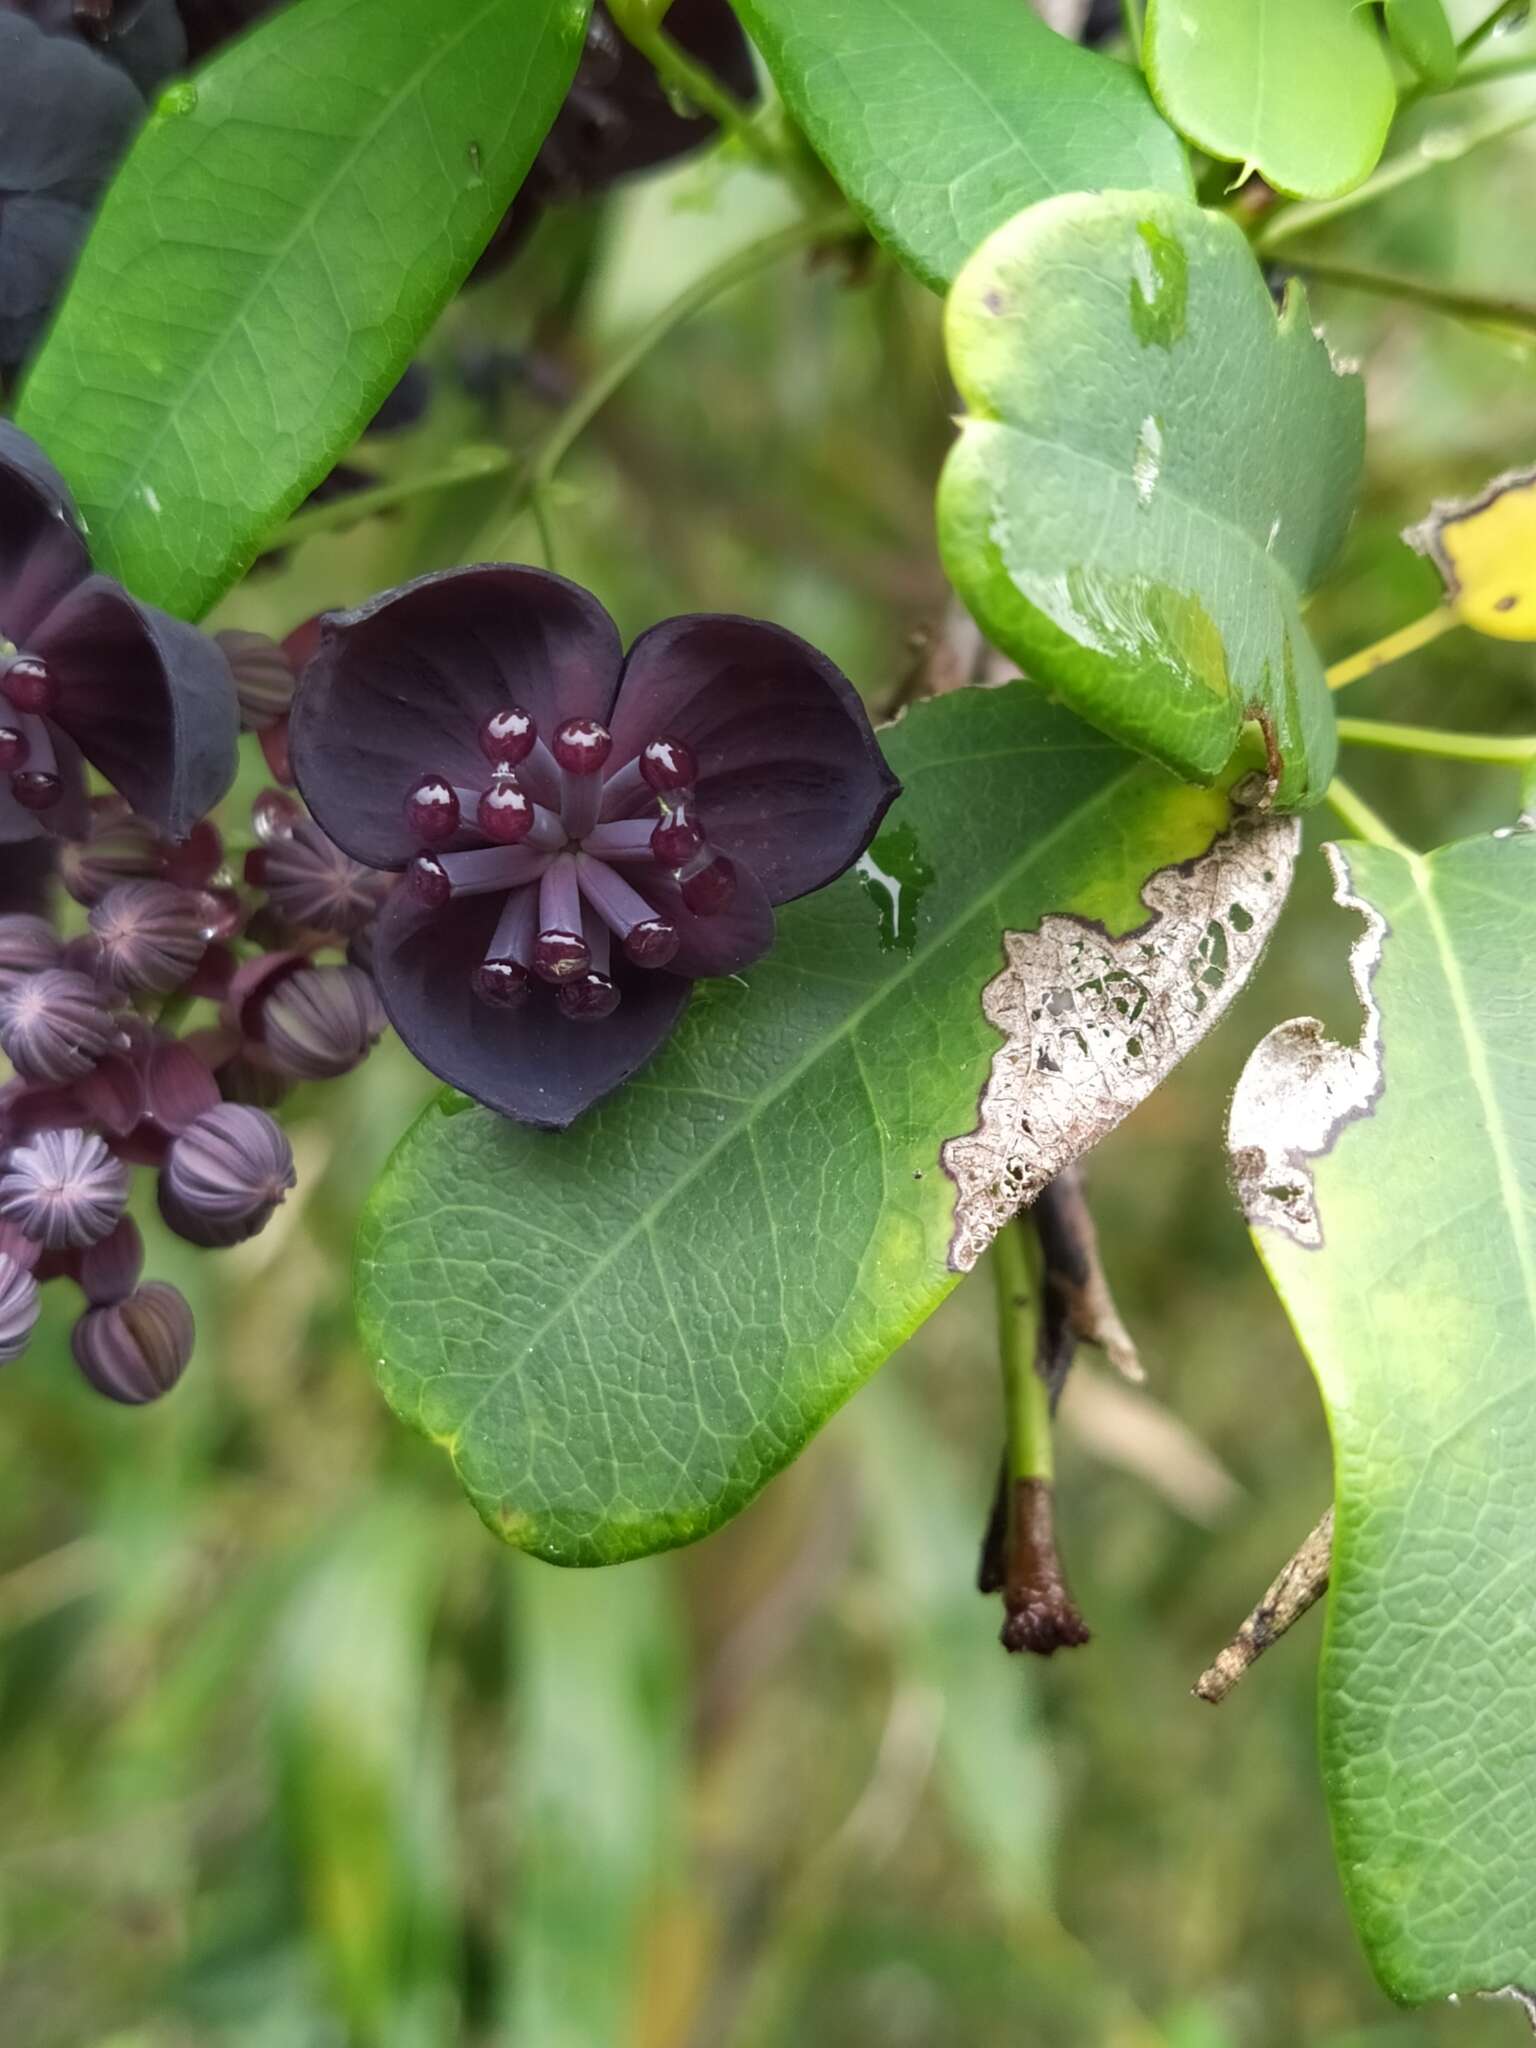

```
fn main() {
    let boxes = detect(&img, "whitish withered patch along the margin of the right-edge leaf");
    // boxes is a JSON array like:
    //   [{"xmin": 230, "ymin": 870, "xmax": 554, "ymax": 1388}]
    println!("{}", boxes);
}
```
[{"xmin": 1227, "ymin": 846, "xmax": 1386, "ymax": 1249}]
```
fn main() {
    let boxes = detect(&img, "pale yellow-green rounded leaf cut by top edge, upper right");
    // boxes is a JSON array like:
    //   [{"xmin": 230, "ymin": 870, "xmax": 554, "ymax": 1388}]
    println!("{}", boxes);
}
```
[{"xmin": 1143, "ymin": 0, "xmax": 1397, "ymax": 199}]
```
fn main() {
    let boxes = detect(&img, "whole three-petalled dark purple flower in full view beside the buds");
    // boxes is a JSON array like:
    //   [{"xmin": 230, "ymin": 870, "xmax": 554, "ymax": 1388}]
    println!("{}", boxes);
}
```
[{"xmin": 293, "ymin": 565, "xmax": 897, "ymax": 1128}]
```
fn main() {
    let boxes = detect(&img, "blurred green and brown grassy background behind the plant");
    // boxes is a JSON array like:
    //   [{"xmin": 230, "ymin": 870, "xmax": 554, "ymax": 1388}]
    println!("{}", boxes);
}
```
[{"xmin": 0, "ymin": 24, "xmax": 1536, "ymax": 2048}]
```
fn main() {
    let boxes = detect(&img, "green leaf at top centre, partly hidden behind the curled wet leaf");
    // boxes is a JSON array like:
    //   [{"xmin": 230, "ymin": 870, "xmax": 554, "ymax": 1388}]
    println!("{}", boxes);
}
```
[{"xmin": 735, "ymin": 0, "xmax": 1192, "ymax": 291}]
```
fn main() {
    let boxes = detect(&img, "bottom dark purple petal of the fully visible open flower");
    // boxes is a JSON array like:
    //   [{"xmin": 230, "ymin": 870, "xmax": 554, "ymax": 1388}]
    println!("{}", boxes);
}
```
[{"xmin": 375, "ymin": 891, "xmax": 690, "ymax": 1130}]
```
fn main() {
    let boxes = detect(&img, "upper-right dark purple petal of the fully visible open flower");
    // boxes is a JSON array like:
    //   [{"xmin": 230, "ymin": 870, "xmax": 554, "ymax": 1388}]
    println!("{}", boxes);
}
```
[{"xmin": 612, "ymin": 614, "xmax": 901, "ymax": 903}]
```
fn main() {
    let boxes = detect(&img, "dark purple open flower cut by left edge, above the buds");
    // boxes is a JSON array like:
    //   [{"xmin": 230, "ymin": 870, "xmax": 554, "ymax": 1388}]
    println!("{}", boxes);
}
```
[{"xmin": 0, "ymin": 417, "xmax": 238, "ymax": 844}]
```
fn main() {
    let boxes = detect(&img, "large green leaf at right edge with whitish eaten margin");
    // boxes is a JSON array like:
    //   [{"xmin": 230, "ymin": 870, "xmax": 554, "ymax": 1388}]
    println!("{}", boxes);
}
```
[{"xmin": 1231, "ymin": 829, "xmax": 1536, "ymax": 2001}]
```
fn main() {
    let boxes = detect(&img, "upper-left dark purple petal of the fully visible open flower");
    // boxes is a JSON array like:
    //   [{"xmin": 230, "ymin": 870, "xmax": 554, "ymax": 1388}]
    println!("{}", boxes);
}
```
[{"xmin": 289, "ymin": 565, "xmax": 623, "ymax": 868}]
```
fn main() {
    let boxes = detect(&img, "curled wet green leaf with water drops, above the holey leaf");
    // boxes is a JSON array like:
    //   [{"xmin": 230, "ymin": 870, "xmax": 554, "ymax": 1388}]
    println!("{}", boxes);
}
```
[{"xmin": 938, "ymin": 193, "xmax": 1364, "ymax": 809}]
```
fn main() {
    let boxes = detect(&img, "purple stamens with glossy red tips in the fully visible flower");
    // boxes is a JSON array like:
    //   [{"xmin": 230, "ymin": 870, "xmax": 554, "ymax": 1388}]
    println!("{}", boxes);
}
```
[{"xmin": 403, "ymin": 705, "xmax": 735, "ymax": 1024}]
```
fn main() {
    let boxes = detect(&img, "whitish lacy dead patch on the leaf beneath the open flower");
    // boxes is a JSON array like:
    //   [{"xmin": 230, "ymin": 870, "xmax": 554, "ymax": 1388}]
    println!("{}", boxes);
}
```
[{"xmin": 940, "ymin": 817, "xmax": 1300, "ymax": 1272}]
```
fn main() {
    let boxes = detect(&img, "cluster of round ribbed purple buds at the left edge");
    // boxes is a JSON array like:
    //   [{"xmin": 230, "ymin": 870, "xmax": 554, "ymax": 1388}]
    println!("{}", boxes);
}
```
[{"xmin": 0, "ymin": 733, "xmax": 389, "ymax": 1403}]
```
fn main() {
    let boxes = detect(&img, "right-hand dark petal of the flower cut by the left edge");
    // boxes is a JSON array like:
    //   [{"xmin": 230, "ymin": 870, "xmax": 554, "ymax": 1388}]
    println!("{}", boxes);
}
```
[{"xmin": 33, "ymin": 575, "xmax": 240, "ymax": 840}]
